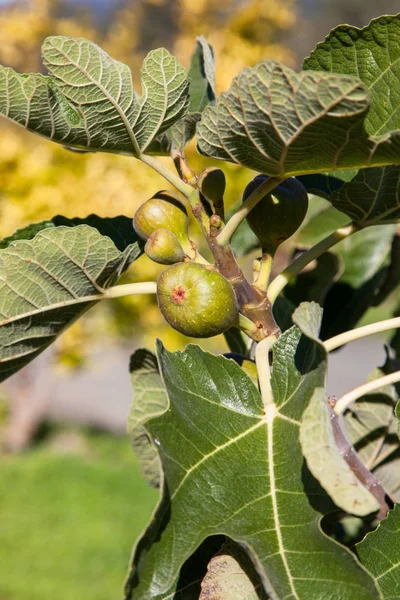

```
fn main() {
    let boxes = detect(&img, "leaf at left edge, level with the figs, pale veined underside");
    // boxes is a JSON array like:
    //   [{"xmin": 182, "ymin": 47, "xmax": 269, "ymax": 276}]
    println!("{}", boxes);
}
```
[{"xmin": 0, "ymin": 217, "xmax": 142, "ymax": 381}]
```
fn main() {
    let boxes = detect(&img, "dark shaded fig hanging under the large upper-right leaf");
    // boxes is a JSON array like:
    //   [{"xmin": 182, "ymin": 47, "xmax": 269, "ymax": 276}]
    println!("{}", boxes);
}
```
[{"xmin": 243, "ymin": 175, "xmax": 308, "ymax": 256}]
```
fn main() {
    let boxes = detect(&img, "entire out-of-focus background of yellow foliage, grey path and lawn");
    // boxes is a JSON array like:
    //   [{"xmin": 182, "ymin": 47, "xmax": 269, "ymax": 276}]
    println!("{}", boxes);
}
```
[{"xmin": 0, "ymin": 0, "xmax": 399, "ymax": 600}]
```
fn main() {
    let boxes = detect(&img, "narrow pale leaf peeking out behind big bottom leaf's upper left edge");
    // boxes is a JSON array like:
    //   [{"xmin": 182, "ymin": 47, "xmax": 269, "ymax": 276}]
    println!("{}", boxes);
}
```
[{"xmin": 128, "ymin": 349, "xmax": 168, "ymax": 488}]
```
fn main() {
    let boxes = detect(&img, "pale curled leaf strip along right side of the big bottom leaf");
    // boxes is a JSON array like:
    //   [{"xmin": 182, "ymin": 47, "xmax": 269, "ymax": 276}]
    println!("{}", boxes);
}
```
[{"xmin": 300, "ymin": 388, "xmax": 379, "ymax": 516}]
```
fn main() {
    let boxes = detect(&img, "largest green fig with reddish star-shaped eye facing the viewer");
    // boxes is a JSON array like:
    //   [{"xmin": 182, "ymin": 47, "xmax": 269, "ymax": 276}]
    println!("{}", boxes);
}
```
[{"xmin": 157, "ymin": 263, "xmax": 239, "ymax": 338}]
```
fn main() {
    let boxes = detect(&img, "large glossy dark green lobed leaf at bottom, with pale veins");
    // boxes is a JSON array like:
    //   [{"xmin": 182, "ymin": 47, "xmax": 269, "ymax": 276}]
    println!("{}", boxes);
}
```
[{"xmin": 126, "ymin": 308, "xmax": 379, "ymax": 600}]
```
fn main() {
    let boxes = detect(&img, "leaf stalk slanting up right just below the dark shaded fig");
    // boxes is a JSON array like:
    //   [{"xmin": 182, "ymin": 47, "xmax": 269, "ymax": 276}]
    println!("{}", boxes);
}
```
[{"xmin": 268, "ymin": 223, "xmax": 358, "ymax": 304}]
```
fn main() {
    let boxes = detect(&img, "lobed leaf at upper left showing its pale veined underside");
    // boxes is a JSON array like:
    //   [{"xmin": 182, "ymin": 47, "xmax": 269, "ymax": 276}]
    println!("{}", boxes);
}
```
[{"xmin": 0, "ymin": 36, "xmax": 189, "ymax": 156}]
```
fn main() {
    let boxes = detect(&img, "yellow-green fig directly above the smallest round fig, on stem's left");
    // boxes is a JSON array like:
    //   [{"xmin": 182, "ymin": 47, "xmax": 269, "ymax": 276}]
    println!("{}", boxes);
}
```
[{"xmin": 133, "ymin": 191, "xmax": 189, "ymax": 246}]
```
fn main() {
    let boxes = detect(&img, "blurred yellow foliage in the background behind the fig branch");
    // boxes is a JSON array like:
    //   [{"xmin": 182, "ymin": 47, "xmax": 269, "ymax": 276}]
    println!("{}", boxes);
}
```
[{"xmin": 0, "ymin": 0, "xmax": 295, "ymax": 366}]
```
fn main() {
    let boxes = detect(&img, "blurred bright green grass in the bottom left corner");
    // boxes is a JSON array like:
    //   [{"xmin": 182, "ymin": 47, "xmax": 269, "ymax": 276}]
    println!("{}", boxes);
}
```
[{"xmin": 0, "ymin": 432, "xmax": 157, "ymax": 600}]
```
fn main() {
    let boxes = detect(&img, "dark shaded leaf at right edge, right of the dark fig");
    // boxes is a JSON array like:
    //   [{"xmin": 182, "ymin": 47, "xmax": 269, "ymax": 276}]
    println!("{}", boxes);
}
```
[{"xmin": 329, "ymin": 166, "xmax": 400, "ymax": 227}]
